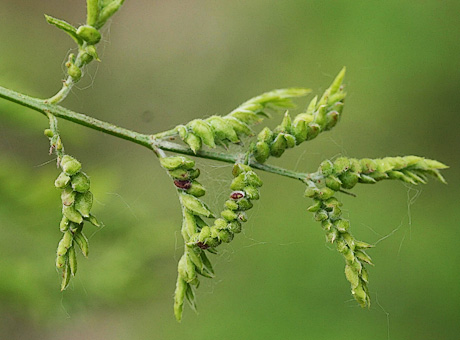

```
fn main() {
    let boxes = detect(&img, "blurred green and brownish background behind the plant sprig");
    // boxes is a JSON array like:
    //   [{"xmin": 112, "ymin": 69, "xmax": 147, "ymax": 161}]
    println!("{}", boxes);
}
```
[{"xmin": 0, "ymin": 0, "xmax": 460, "ymax": 340}]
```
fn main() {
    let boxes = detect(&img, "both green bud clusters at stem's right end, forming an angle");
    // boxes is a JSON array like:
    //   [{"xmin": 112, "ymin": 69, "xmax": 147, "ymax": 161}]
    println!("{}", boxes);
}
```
[{"xmin": 305, "ymin": 156, "xmax": 447, "ymax": 307}]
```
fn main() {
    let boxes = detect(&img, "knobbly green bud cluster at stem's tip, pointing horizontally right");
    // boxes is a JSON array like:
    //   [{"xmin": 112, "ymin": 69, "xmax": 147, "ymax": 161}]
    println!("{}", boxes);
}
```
[{"xmin": 313, "ymin": 156, "xmax": 447, "ymax": 191}]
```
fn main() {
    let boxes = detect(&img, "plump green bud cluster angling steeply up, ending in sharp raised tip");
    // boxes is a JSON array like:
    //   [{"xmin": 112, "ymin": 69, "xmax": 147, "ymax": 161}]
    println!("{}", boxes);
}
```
[{"xmin": 253, "ymin": 68, "xmax": 346, "ymax": 163}]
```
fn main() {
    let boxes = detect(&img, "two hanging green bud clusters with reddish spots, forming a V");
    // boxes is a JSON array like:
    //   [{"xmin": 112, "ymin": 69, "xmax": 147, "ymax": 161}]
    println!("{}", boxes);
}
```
[{"xmin": 160, "ymin": 156, "xmax": 262, "ymax": 321}]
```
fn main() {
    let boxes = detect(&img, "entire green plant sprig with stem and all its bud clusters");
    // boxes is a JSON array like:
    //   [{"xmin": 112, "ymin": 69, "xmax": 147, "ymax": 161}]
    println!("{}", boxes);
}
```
[{"xmin": 0, "ymin": 0, "xmax": 447, "ymax": 321}]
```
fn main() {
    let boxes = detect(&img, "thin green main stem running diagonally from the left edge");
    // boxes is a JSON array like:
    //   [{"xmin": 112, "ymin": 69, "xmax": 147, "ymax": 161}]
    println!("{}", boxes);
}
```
[{"xmin": 0, "ymin": 86, "xmax": 308, "ymax": 181}]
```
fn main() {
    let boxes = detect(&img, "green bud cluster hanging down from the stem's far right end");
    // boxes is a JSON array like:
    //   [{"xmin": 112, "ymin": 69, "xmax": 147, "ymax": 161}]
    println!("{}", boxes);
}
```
[{"xmin": 307, "ymin": 190, "xmax": 373, "ymax": 307}]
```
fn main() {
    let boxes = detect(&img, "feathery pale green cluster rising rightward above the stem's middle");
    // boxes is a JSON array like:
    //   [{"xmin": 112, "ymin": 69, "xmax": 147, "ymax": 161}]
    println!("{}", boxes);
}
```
[{"xmin": 175, "ymin": 88, "xmax": 309, "ymax": 153}]
